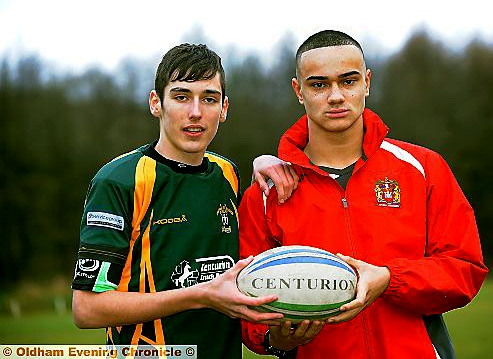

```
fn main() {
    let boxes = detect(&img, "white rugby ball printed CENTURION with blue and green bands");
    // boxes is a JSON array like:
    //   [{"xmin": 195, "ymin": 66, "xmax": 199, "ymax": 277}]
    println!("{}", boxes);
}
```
[{"xmin": 236, "ymin": 246, "xmax": 357, "ymax": 323}]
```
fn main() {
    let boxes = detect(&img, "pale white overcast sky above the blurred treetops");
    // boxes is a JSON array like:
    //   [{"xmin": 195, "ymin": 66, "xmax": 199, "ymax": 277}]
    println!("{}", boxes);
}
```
[{"xmin": 0, "ymin": 0, "xmax": 493, "ymax": 70}]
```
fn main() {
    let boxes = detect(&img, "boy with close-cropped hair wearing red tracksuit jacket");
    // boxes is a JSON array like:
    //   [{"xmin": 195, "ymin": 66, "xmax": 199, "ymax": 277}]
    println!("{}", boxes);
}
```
[{"xmin": 239, "ymin": 31, "xmax": 487, "ymax": 359}]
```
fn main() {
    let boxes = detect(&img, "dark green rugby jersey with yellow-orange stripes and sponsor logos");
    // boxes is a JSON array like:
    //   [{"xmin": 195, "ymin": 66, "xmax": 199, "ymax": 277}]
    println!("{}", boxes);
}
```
[{"xmin": 72, "ymin": 144, "xmax": 242, "ymax": 359}]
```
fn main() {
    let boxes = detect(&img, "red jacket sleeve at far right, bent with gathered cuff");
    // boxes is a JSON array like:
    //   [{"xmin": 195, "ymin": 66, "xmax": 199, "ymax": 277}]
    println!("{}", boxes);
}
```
[{"xmin": 384, "ymin": 153, "xmax": 488, "ymax": 314}]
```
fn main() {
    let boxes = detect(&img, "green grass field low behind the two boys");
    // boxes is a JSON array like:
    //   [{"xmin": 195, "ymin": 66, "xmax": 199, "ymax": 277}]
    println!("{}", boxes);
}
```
[{"xmin": 0, "ymin": 281, "xmax": 493, "ymax": 359}]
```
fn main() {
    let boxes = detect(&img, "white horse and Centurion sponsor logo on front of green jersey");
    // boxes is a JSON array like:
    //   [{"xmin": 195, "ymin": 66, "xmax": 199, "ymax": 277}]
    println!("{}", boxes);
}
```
[{"xmin": 171, "ymin": 256, "xmax": 235, "ymax": 288}]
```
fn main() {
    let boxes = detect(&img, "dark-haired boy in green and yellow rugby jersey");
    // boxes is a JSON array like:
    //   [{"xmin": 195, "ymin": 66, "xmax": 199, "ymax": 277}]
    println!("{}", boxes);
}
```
[{"xmin": 72, "ymin": 44, "xmax": 285, "ymax": 359}]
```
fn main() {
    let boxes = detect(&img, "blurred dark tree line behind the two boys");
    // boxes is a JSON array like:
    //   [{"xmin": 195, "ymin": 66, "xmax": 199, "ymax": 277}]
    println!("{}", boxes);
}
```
[{"xmin": 0, "ymin": 32, "xmax": 493, "ymax": 286}]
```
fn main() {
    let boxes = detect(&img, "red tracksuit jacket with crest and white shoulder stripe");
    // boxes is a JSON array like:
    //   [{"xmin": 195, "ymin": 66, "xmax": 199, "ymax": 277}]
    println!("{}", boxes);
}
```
[{"xmin": 239, "ymin": 109, "xmax": 488, "ymax": 359}]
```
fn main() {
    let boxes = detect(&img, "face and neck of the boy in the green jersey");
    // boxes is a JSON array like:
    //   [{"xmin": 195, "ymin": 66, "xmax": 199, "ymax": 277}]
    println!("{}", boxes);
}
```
[{"xmin": 149, "ymin": 74, "xmax": 228, "ymax": 165}]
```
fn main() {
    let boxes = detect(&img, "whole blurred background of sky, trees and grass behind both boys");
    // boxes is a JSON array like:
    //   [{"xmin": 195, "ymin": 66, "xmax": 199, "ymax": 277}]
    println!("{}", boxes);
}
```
[{"xmin": 0, "ymin": 0, "xmax": 493, "ymax": 358}]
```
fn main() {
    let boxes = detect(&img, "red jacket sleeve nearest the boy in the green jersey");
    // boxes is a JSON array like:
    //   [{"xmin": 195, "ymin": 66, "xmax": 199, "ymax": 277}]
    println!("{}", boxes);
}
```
[{"xmin": 238, "ymin": 184, "xmax": 278, "ymax": 354}]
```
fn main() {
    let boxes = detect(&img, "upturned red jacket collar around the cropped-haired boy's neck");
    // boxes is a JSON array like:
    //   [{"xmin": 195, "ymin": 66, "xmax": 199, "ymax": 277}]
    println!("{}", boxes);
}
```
[{"xmin": 278, "ymin": 108, "xmax": 389, "ymax": 167}]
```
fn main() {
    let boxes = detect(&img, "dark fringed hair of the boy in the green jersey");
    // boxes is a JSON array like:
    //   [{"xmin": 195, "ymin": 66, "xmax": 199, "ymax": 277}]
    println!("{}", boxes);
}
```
[{"xmin": 154, "ymin": 43, "xmax": 226, "ymax": 100}]
